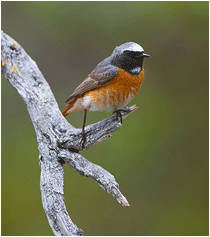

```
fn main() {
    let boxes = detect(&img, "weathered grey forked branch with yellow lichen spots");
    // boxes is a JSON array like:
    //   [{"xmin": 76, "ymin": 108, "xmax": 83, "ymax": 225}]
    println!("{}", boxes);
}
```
[{"xmin": 1, "ymin": 32, "xmax": 137, "ymax": 236}]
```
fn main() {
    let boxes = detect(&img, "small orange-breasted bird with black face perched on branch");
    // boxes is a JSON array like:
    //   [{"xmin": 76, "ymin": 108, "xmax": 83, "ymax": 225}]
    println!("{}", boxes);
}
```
[{"xmin": 62, "ymin": 42, "xmax": 151, "ymax": 143}]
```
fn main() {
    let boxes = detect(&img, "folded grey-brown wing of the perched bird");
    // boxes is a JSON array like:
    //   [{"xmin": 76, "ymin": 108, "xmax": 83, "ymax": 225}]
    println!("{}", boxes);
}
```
[{"xmin": 65, "ymin": 61, "xmax": 119, "ymax": 103}]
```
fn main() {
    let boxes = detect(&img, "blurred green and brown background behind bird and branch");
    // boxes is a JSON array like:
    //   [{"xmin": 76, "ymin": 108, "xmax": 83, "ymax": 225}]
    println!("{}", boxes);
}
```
[{"xmin": 1, "ymin": 2, "xmax": 209, "ymax": 235}]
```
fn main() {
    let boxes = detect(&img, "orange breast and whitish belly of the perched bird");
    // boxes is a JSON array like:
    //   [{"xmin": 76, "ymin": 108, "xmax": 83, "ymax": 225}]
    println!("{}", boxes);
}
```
[{"xmin": 84, "ymin": 67, "xmax": 144, "ymax": 111}]
